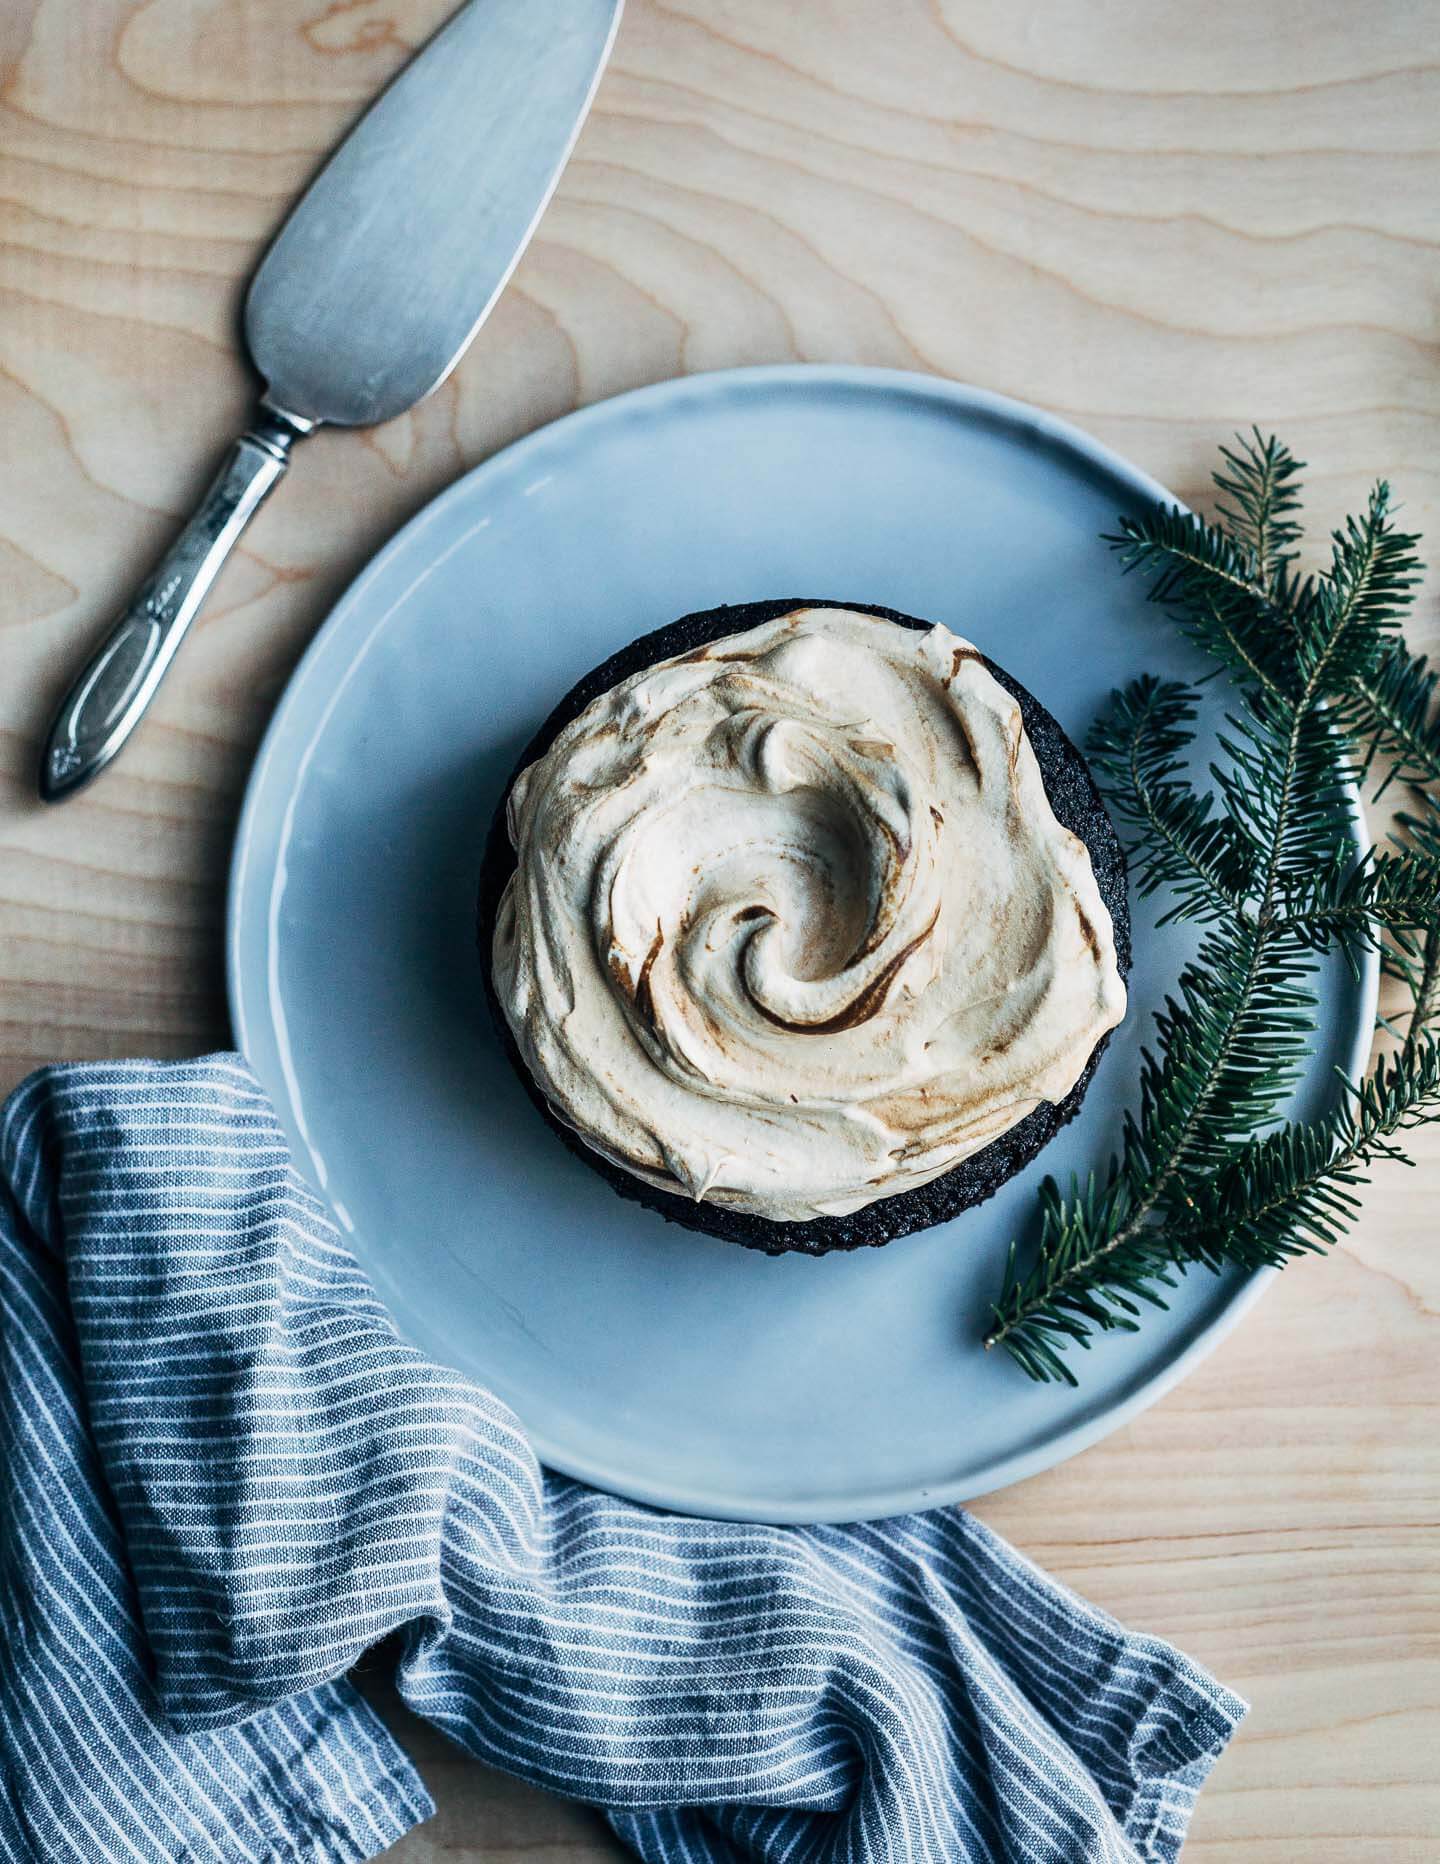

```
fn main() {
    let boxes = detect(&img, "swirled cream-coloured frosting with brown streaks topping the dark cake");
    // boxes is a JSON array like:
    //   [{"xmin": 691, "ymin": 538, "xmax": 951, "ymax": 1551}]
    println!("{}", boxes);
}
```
[{"xmin": 494, "ymin": 608, "xmax": 1125, "ymax": 1223}]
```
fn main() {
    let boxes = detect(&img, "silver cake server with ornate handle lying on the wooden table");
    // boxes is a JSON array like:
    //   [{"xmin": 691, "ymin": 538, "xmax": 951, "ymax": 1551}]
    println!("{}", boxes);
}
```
[{"xmin": 39, "ymin": 0, "xmax": 624, "ymax": 802}]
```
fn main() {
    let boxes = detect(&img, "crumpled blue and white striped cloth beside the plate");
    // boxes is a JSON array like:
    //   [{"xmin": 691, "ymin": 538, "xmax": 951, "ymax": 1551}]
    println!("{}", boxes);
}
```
[{"xmin": 0, "ymin": 1057, "xmax": 1244, "ymax": 1864}]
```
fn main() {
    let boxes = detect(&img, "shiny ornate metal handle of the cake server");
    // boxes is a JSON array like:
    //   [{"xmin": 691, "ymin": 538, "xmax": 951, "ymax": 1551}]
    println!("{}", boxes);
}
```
[{"xmin": 39, "ymin": 408, "xmax": 304, "ymax": 803}]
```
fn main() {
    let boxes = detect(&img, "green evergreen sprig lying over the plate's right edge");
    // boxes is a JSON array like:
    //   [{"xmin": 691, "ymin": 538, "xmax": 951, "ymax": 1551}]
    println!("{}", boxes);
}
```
[{"xmin": 985, "ymin": 432, "xmax": 1440, "ymax": 1385}]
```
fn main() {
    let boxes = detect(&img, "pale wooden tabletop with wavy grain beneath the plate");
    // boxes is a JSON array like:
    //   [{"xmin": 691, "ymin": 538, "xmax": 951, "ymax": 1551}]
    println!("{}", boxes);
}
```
[{"xmin": 0, "ymin": 0, "xmax": 1440, "ymax": 1864}]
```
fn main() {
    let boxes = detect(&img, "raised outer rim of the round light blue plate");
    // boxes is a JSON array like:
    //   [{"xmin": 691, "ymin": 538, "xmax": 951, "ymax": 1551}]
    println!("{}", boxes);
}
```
[{"xmin": 224, "ymin": 362, "xmax": 1380, "ymax": 1525}]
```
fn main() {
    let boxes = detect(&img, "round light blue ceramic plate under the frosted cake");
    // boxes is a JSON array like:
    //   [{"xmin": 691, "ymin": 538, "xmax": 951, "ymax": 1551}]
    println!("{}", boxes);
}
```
[{"xmin": 229, "ymin": 367, "xmax": 1375, "ymax": 1521}]
